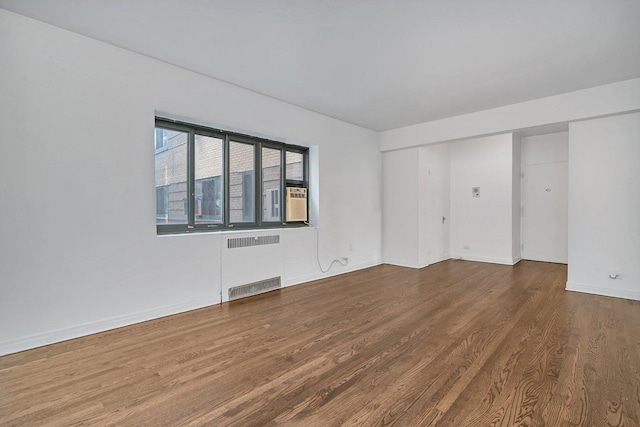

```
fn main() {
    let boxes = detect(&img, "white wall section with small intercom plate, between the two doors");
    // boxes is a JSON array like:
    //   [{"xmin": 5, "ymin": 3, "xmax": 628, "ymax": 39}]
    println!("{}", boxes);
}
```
[{"xmin": 451, "ymin": 133, "xmax": 519, "ymax": 264}]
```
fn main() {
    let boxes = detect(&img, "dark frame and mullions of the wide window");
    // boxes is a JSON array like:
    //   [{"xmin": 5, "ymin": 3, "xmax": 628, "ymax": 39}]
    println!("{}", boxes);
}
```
[{"xmin": 154, "ymin": 117, "xmax": 309, "ymax": 235}]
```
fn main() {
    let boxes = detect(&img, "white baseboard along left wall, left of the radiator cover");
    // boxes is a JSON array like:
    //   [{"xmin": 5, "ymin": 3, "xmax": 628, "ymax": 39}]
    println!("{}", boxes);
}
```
[{"xmin": 0, "ymin": 296, "xmax": 220, "ymax": 356}]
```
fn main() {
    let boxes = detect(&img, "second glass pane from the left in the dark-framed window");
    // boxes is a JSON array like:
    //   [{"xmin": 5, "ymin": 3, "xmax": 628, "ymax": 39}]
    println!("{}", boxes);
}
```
[{"xmin": 194, "ymin": 135, "xmax": 224, "ymax": 224}]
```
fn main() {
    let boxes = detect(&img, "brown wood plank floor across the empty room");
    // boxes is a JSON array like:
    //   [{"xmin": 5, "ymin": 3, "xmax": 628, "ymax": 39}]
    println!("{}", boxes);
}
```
[{"xmin": 0, "ymin": 260, "xmax": 640, "ymax": 427}]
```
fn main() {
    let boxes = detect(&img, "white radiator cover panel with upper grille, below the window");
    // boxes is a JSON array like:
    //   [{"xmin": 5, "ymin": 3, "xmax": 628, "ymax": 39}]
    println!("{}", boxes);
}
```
[{"xmin": 220, "ymin": 231, "xmax": 284, "ymax": 302}]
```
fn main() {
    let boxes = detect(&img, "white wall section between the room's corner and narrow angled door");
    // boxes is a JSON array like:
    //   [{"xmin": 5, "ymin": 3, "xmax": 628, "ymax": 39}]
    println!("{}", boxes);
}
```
[{"xmin": 382, "ymin": 148, "xmax": 423, "ymax": 268}]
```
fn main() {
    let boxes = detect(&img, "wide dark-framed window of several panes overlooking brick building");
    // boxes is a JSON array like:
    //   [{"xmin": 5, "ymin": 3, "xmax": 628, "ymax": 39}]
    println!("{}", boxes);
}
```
[{"xmin": 155, "ymin": 118, "xmax": 308, "ymax": 234}]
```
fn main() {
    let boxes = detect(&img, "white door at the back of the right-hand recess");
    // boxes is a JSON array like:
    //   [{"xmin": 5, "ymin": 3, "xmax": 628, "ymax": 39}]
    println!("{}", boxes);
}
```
[{"xmin": 522, "ymin": 162, "xmax": 568, "ymax": 264}]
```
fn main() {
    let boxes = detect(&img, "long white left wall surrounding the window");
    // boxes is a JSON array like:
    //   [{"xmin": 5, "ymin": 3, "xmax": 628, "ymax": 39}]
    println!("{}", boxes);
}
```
[{"xmin": 0, "ymin": 10, "xmax": 382, "ymax": 354}]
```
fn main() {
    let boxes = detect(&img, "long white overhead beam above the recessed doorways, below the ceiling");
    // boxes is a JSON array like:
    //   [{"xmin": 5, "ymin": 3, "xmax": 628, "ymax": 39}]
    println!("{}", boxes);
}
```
[{"xmin": 380, "ymin": 78, "xmax": 640, "ymax": 151}]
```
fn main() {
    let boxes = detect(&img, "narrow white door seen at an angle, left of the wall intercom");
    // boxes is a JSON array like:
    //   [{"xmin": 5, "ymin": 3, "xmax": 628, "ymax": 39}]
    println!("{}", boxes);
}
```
[{"xmin": 427, "ymin": 163, "xmax": 449, "ymax": 264}]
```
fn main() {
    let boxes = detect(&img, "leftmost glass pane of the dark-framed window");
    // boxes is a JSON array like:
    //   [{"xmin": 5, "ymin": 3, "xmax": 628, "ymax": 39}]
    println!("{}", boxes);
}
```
[{"xmin": 155, "ymin": 129, "xmax": 189, "ymax": 224}]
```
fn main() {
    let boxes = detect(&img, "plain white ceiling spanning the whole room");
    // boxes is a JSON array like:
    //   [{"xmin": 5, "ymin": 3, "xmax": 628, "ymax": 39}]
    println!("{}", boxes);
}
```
[{"xmin": 0, "ymin": 0, "xmax": 640, "ymax": 130}]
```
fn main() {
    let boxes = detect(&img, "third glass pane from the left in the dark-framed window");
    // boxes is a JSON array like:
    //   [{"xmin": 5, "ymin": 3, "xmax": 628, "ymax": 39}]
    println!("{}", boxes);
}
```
[{"xmin": 229, "ymin": 141, "xmax": 256, "ymax": 223}]
